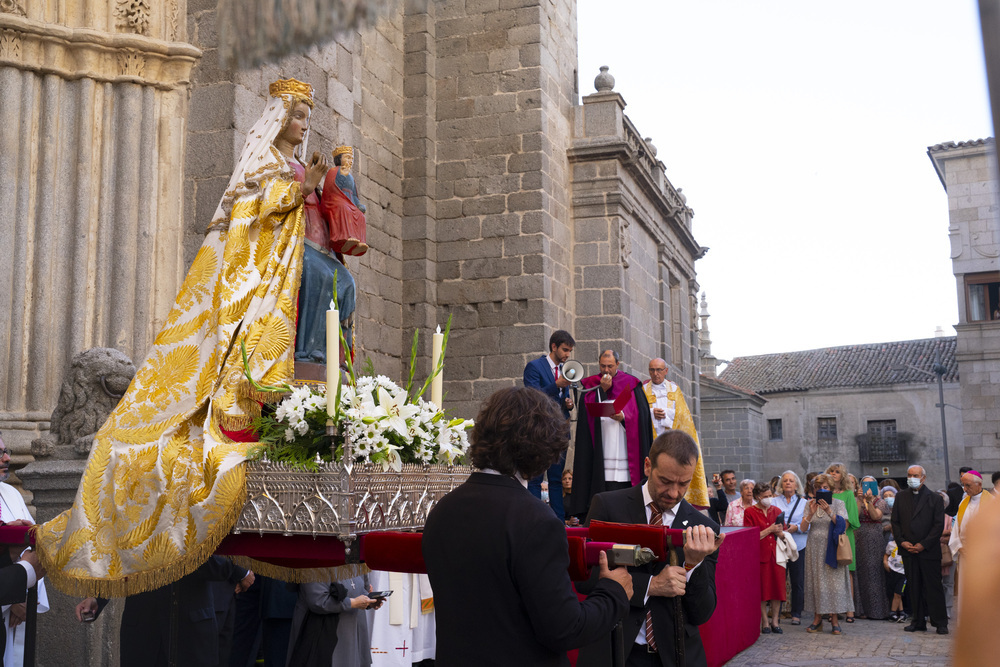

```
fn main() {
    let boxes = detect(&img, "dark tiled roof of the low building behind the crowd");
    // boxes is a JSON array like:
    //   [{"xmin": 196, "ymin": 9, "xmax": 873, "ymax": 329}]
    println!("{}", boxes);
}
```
[{"xmin": 719, "ymin": 336, "xmax": 958, "ymax": 394}]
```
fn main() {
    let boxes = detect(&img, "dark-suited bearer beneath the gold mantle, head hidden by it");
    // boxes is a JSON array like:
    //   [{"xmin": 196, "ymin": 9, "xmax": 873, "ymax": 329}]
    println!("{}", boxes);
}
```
[{"xmin": 76, "ymin": 556, "xmax": 254, "ymax": 667}]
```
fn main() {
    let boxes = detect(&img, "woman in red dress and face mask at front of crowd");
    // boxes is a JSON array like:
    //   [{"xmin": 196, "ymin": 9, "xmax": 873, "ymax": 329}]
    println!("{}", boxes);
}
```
[{"xmin": 743, "ymin": 482, "xmax": 785, "ymax": 635}]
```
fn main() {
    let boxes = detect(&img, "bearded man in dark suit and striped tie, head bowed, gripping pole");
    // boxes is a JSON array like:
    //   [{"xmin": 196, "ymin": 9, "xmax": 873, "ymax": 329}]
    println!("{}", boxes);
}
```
[{"xmin": 577, "ymin": 430, "xmax": 721, "ymax": 667}]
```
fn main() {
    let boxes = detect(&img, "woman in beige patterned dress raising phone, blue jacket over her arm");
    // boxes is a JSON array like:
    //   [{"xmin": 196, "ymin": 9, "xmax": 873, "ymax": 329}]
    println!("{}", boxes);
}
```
[{"xmin": 799, "ymin": 474, "xmax": 854, "ymax": 635}]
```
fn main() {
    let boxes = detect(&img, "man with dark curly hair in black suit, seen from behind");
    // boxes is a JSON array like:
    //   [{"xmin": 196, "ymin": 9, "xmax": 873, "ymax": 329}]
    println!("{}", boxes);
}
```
[{"xmin": 423, "ymin": 387, "xmax": 632, "ymax": 667}]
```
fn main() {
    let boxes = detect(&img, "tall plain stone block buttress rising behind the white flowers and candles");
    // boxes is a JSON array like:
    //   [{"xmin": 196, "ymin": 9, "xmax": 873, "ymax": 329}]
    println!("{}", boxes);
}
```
[{"xmin": 426, "ymin": 0, "xmax": 576, "ymax": 415}]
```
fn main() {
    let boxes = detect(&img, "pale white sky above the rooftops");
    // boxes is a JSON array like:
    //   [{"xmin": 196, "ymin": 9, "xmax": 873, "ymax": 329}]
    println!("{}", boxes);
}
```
[{"xmin": 577, "ymin": 0, "xmax": 993, "ymax": 366}]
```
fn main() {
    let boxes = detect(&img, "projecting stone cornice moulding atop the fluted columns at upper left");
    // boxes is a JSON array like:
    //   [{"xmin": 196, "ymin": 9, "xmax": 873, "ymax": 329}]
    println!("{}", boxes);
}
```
[{"xmin": 0, "ymin": 14, "xmax": 201, "ymax": 90}]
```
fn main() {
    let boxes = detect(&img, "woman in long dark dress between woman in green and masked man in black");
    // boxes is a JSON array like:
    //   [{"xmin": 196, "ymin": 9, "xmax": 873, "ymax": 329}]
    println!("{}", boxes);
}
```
[{"xmin": 854, "ymin": 475, "xmax": 889, "ymax": 620}]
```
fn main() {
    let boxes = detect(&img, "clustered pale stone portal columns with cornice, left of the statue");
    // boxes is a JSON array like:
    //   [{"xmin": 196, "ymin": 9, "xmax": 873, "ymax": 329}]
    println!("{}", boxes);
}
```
[{"xmin": 0, "ymin": 0, "xmax": 201, "ymax": 474}]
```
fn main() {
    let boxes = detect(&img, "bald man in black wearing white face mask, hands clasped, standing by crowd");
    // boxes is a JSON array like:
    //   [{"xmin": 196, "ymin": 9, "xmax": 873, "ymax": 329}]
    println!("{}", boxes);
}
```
[{"xmin": 891, "ymin": 465, "xmax": 948, "ymax": 635}]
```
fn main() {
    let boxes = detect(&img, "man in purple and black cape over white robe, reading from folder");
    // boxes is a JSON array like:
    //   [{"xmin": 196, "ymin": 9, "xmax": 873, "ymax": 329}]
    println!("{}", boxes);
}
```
[{"xmin": 567, "ymin": 350, "xmax": 653, "ymax": 517}]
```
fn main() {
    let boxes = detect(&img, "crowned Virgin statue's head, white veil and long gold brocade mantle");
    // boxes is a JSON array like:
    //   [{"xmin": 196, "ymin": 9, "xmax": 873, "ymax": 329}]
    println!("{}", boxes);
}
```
[{"xmin": 36, "ymin": 79, "xmax": 327, "ymax": 597}]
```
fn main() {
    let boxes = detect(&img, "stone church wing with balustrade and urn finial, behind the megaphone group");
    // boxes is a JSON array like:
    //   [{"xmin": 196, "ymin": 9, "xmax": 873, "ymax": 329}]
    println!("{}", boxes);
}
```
[{"xmin": 569, "ymin": 83, "xmax": 702, "ymax": 396}]
